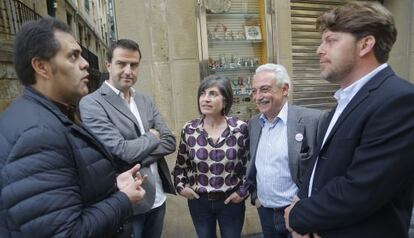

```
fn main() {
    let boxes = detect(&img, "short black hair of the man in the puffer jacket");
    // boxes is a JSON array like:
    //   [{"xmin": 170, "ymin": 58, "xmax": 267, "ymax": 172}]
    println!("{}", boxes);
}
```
[{"xmin": 14, "ymin": 17, "xmax": 71, "ymax": 86}]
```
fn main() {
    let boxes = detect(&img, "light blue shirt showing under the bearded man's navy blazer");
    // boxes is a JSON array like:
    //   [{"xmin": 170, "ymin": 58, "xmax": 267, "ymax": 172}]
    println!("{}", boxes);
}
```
[{"xmin": 308, "ymin": 63, "xmax": 388, "ymax": 197}]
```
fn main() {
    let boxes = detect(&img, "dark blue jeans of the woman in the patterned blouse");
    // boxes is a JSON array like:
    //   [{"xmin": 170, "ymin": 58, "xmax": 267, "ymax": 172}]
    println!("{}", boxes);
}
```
[{"xmin": 188, "ymin": 197, "xmax": 246, "ymax": 238}]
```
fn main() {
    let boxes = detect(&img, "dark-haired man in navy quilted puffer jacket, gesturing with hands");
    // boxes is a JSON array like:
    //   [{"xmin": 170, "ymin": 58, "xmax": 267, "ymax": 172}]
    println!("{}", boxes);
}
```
[{"xmin": 0, "ymin": 18, "xmax": 144, "ymax": 237}]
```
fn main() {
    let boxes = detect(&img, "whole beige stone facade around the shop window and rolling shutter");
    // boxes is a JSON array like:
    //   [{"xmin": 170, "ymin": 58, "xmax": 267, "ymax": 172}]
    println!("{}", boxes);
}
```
[{"xmin": 115, "ymin": 0, "xmax": 414, "ymax": 238}]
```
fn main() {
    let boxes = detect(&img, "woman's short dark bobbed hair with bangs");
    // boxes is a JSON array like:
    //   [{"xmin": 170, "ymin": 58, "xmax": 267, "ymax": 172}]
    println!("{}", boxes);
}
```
[{"xmin": 197, "ymin": 75, "xmax": 233, "ymax": 115}]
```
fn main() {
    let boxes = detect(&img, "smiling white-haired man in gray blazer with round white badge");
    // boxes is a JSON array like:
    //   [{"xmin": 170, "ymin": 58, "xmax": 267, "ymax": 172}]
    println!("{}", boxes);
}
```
[{"xmin": 246, "ymin": 64, "xmax": 325, "ymax": 238}]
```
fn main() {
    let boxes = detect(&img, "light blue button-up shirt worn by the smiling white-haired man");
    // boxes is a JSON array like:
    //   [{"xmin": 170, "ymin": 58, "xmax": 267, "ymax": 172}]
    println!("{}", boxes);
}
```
[{"xmin": 255, "ymin": 103, "xmax": 298, "ymax": 208}]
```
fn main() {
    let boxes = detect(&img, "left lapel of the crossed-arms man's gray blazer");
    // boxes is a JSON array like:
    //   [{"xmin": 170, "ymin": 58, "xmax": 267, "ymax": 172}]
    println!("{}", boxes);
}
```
[{"xmin": 98, "ymin": 83, "xmax": 141, "ymax": 128}]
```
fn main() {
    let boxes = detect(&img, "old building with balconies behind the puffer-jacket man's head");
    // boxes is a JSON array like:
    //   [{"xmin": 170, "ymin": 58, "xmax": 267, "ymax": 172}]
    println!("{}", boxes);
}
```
[{"xmin": 0, "ymin": 0, "xmax": 110, "ymax": 112}]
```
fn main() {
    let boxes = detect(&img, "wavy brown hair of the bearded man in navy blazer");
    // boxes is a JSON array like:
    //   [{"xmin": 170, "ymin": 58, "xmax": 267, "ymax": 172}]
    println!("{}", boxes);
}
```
[{"xmin": 316, "ymin": 2, "xmax": 397, "ymax": 63}]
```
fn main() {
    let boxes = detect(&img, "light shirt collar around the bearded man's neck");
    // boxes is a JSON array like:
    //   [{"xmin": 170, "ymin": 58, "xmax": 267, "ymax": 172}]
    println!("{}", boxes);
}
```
[{"xmin": 334, "ymin": 63, "xmax": 388, "ymax": 103}]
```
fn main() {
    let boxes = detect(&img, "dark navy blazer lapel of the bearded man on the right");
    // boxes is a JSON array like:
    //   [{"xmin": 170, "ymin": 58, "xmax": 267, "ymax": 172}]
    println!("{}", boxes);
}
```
[{"xmin": 321, "ymin": 66, "xmax": 395, "ymax": 151}]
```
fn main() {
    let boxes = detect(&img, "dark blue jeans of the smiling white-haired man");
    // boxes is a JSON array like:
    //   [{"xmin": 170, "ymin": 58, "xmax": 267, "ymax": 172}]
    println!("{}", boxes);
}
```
[{"xmin": 257, "ymin": 206, "xmax": 292, "ymax": 238}]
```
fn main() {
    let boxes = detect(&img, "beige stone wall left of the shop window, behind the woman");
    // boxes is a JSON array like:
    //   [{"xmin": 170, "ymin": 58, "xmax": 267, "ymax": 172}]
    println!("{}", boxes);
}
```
[{"xmin": 115, "ymin": 0, "xmax": 260, "ymax": 238}]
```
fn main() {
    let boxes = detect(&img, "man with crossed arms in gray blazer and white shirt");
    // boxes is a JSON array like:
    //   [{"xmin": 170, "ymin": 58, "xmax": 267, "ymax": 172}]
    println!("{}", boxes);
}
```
[{"xmin": 80, "ymin": 39, "xmax": 176, "ymax": 238}]
